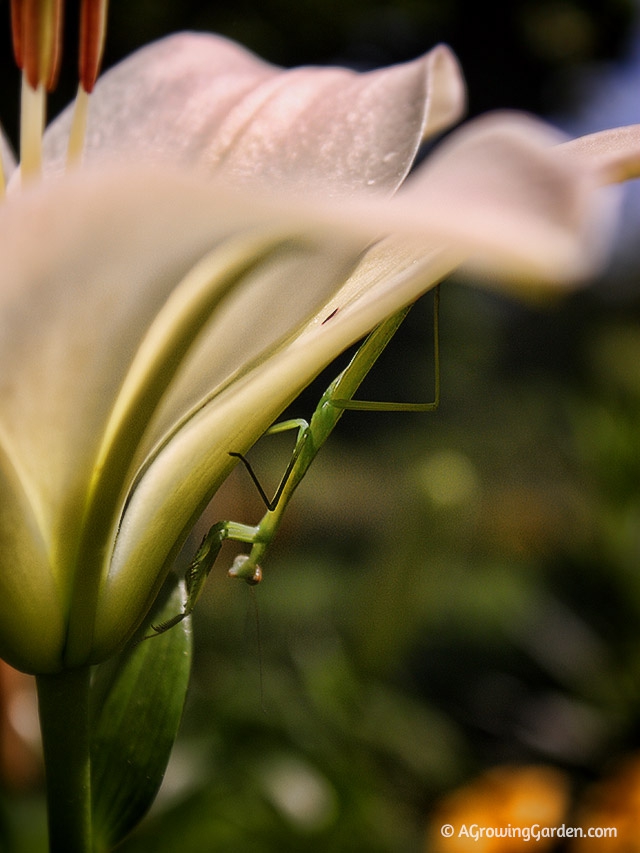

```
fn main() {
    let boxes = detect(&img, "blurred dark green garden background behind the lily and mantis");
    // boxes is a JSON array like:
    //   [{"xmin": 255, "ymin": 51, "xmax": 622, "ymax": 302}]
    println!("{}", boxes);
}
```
[{"xmin": 0, "ymin": 0, "xmax": 640, "ymax": 853}]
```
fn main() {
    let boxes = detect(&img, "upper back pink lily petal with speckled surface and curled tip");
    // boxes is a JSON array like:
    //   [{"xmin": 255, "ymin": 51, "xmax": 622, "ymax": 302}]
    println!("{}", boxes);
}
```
[{"xmin": 44, "ymin": 33, "xmax": 465, "ymax": 195}]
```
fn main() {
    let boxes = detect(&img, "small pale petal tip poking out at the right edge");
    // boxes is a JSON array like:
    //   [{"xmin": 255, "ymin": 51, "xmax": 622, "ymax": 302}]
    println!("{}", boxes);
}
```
[{"xmin": 559, "ymin": 124, "xmax": 640, "ymax": 184}]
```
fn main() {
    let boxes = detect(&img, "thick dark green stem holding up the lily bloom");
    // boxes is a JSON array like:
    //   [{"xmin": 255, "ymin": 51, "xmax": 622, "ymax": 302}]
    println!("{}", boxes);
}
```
[{"xmin": 37, "ymin": 667, "xmax": 93, "ymax": 853}]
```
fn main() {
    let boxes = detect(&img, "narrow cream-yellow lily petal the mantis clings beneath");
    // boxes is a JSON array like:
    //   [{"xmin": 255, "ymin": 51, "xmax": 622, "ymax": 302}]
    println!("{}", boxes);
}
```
[{"xmin": 94, "ymin": 241, "xmax": 456, "ymax": 660}]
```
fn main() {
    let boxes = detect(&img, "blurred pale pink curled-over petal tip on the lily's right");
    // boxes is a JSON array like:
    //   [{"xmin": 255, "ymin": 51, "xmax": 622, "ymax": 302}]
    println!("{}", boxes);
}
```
[{"xmin": 342, "ymin": 113, "xmax": 617, "ymax": 287}]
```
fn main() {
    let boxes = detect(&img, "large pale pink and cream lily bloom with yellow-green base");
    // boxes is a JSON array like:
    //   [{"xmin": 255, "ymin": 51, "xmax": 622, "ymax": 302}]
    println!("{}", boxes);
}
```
[{"xmin": 0, "ymin": 8, "xmax": 639, "ymax": 673}]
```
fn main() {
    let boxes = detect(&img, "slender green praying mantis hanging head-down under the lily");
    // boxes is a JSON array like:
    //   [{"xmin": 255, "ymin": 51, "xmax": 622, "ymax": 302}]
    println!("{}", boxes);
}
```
[{"xmin": 150, "ymin": 285, "xmax": 440, "ymax": 636}]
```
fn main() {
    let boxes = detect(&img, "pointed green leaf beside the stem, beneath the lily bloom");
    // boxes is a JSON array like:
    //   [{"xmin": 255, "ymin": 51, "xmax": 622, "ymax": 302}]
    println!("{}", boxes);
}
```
[{"xmin": 91, "ymin": 578, "xmax": 192, "ymax": 846}]
